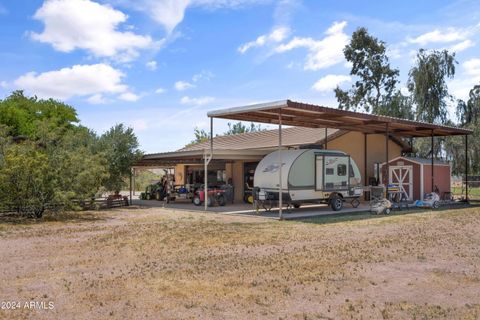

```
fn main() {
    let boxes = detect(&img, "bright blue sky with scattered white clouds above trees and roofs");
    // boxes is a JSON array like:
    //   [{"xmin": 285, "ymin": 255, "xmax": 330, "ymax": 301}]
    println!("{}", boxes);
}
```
[{"xmin": 0, "ymin": 0, "xmax": 480, "ymax": 152}]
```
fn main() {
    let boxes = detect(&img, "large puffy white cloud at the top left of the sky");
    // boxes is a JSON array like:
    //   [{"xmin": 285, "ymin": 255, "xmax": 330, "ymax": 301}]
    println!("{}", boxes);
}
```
[{"xmin": 31, "ymin": 0, "xmax": 154, "ymax": 62}]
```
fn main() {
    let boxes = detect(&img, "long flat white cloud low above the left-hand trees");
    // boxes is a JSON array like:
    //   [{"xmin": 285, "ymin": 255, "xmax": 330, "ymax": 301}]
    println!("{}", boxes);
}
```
[{"xmin": 14, "ymin": 63, "xmax": 128, "ymax": 101}]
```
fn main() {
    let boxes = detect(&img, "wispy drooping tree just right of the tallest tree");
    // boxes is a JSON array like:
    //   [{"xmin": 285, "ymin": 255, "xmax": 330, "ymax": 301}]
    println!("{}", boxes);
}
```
[{"xmin": 408, "ymin": 49, "xmax": 456, "ymax": 123}]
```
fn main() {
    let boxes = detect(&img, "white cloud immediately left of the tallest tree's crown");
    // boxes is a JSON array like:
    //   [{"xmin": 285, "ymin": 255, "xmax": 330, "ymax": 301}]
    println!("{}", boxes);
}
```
[{"xmin": 275, "ymin": 21, "xmax": 349, "ymax": 70}]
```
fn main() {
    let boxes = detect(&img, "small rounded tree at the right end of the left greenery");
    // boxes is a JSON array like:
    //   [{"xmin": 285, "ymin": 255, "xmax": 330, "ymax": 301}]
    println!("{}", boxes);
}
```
[{"xmin": 98, "ymin": 124, "xmax": 142, "ymax": 192}]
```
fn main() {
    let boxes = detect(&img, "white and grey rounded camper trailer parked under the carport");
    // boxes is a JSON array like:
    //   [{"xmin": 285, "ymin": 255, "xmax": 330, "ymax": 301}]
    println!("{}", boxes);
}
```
[{"xmin": 254, "ymin": 149, "xmax": 363, "ymax": 211}]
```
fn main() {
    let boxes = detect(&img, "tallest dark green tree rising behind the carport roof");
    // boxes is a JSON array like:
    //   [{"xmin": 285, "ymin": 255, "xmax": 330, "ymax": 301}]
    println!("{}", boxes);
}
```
[{"xmin": 335, "ymin": 28, "xmax": 399, "ymax": 114}]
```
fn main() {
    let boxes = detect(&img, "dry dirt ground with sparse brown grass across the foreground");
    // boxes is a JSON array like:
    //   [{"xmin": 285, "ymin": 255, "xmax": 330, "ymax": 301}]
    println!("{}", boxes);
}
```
[{"xmin": 0, "ymin": 208, "xmax": 480, "ymax": 319}]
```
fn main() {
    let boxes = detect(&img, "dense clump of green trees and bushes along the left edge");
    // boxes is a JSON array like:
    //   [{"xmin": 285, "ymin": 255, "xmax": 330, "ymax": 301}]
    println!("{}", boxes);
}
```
[{"xmin": 0, "ymin": 91, "xmax": 141, "ymax": 217}]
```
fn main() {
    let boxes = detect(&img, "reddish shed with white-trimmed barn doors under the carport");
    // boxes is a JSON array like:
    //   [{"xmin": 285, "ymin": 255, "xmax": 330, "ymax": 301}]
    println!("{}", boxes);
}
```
[{"xmin": 380, "ymin": 157, "xmax": 451, "ymax": 201}]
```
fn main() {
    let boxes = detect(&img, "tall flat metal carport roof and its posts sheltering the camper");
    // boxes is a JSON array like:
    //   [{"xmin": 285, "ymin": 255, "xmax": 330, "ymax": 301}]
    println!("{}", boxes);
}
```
[{"xmin": 205, "ymin": 100, "xmax": 472, "ymax": 219}]
